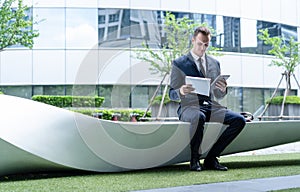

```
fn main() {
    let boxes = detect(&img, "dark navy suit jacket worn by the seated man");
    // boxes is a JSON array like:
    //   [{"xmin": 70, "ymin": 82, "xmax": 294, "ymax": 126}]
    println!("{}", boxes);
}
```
[{"xmin": 169, "ymin": 53, "xmax": 227, "ymax": 115}]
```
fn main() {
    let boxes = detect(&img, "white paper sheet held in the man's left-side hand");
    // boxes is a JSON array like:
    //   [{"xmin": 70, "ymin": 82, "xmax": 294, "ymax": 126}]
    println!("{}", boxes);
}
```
[{"xmin": 185, "ymin": 76, "xmax": 210, "ymax": 96}]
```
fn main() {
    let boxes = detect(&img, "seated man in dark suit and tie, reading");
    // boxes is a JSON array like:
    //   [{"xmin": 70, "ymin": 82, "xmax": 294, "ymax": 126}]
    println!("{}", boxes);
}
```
[{"xmin": 169, "ymin": 27, "xmax": 246, "ymax": 171}]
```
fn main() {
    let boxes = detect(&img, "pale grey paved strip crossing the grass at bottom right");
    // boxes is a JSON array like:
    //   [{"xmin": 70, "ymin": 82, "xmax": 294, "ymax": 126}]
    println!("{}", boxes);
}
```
[{"xmin": 135, "ymin": 175, "xmax": 300, "ymax": 192}]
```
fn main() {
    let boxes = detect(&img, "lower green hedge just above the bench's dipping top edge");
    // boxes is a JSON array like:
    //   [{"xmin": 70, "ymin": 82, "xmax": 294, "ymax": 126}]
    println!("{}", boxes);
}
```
[{"xmin": 70, "ymin": 109, "xmax": 151, "ymax": 121}]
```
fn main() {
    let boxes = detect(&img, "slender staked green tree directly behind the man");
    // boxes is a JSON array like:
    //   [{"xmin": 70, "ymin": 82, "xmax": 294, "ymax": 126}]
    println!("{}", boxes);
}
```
[{"xmin": 135, "ymin": 12, "xmax": 220, "ymax": 116}]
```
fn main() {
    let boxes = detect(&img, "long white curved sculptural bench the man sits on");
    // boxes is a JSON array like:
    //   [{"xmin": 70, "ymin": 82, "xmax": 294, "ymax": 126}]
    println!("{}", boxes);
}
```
[{"xmin": 0, "ymin": 95, "xmax": 300, "ymax": 175}]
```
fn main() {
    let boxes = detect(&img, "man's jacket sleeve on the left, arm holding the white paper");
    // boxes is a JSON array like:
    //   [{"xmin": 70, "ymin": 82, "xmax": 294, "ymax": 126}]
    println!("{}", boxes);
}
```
[{"xmin": 169, "ymin": 60, "xmax": 185, "ymax": 101}]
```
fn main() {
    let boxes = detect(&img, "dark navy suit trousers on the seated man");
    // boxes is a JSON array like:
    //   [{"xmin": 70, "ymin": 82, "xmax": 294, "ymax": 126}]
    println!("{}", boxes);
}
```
[{"xmin": 179, "ymin": 105, "xmax": 246, "ymax": 159}]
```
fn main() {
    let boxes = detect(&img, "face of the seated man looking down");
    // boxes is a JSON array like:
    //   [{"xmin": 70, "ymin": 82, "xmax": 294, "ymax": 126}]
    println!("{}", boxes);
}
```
[{"xmin": 192, "ymin": 33, "xmax": 210, "ymax": 57}]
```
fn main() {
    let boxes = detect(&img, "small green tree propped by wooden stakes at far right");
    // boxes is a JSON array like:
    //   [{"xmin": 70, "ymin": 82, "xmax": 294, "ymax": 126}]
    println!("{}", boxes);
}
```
[{"xmin": 258, "ymin": 29, "xmax": 300, "ymax": 95}]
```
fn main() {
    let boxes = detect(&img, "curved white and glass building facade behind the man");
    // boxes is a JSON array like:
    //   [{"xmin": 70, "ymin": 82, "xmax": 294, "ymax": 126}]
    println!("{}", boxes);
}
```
[{"xmin": 0, "ymin": 0, "xmax": 300, "ymax": 113}]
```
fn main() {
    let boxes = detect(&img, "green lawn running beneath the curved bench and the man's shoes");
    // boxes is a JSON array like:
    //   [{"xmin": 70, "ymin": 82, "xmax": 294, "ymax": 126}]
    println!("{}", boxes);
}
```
[{"xmin": 0, "ymin": 153, "xmax": 300, "ymax": 192}]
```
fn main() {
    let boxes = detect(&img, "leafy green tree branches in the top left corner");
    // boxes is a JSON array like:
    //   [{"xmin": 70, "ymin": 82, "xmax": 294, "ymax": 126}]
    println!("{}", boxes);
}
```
[{"xmin": 0, "ymin": 0, "xmax": 39, "ymax": 52}]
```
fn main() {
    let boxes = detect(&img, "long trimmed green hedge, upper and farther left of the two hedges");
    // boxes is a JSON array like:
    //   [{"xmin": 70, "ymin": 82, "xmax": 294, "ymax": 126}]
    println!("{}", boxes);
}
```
[{"xmin": 31, "ymin": 95, "xmax": 104, "ymax": 108}]
